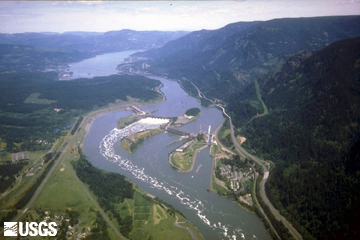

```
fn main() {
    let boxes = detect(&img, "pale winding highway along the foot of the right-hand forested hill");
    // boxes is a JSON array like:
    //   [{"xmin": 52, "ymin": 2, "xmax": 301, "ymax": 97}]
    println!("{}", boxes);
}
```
[{"xmin": 191, "ymin": 82, "xmax": 303, "ymax": 240}]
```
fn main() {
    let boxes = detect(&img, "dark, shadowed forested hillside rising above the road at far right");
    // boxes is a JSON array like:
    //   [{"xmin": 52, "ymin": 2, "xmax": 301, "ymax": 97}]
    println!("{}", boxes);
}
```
[{"xmin": 228, "ymin": 38, "xmax": 360, "ymax": 239}]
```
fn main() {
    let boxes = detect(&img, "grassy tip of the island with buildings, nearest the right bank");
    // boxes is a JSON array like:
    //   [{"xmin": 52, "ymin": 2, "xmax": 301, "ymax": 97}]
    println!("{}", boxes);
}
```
[{"xmin": 170, "ymin": 140, "xmax": 205, "ymax": 171}]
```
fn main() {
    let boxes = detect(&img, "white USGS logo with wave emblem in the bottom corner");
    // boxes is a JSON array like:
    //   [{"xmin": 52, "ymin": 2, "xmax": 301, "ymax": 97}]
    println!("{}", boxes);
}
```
[{"xmin": 4, "ymin": 222, "xmax": 57, "ymax": 237}]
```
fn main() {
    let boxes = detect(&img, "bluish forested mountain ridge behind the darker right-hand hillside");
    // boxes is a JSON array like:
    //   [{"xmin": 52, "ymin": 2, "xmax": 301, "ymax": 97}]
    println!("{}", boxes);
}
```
[{"xmin": 136, "ymin": 16, "xmax": 360, "ymax": 100}]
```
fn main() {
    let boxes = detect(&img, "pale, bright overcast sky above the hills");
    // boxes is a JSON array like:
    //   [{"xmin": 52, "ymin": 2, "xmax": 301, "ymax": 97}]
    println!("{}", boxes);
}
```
[{"xmin": 0, "ymin": 0, "xmax": 360, "ymax": 33}]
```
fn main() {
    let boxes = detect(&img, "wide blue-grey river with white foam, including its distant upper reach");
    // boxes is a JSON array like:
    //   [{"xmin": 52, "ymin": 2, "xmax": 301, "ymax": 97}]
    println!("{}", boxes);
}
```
[{"xmin": 63, "ymin": 51, "xmax": 271, "ymax": 240}]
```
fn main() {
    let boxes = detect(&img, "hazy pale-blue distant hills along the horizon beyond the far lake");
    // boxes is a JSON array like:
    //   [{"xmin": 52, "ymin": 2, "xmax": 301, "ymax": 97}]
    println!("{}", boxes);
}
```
[{"xmin": 0, "ymin": 29, "xmax": 187, "ymax": 54}]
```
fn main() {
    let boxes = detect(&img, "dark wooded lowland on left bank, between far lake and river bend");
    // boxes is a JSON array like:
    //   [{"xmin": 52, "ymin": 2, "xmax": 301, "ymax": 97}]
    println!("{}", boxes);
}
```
[{"xmin": 0, "ymin": 72, "xmax": 160, "ymax": 152}]
